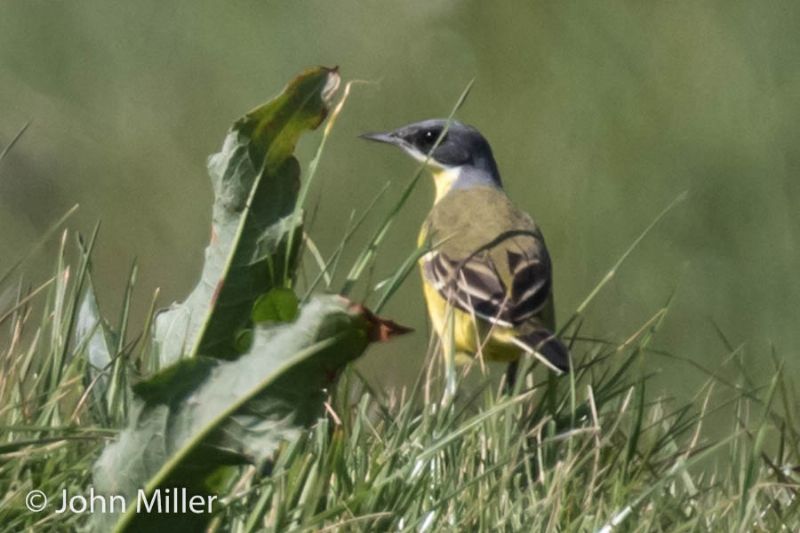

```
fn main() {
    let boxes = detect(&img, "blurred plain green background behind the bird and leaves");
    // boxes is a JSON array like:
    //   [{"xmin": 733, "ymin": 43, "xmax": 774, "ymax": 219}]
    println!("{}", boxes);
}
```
[{"xmin": 0, "ymin": 0, "xmax": 800, "ymax": 395}]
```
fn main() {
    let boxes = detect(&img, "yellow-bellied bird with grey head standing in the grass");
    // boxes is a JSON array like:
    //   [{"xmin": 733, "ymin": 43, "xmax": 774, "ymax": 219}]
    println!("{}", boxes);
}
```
[{"xmin": 361, "ymin": 119, "xmax": 570, "ymax": 395}]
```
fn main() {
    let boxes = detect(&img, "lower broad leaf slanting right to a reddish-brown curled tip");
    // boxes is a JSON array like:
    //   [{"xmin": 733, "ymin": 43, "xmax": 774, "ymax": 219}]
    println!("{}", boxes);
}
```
[{"xmin": 93, "ymin": 296, "xmax": 394, "ymax": 533}]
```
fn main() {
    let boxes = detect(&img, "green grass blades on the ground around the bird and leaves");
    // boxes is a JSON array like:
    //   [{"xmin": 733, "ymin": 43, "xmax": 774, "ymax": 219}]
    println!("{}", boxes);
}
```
[{"xmin": 0, "ymin": 90, "xmax": 800, "ymax": 532}]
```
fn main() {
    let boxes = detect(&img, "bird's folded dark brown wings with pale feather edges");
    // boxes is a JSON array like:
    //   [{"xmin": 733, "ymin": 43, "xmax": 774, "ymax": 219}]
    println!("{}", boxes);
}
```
[{"xmin": 422, "ymin": 234, "xmax": 551, "ymax": 327}]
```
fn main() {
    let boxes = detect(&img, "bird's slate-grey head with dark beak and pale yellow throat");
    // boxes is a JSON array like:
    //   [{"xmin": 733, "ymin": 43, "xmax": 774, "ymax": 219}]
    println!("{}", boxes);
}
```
[{"xmin": 361, "ymin": 119, "xmax": 500, "ymax": 200}]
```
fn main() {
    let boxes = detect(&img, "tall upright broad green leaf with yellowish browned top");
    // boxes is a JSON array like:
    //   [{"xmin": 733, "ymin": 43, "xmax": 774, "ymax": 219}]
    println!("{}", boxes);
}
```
[{"xmin": 154, "ymin": 67, "xmax": 339, "ymax": 367}]
